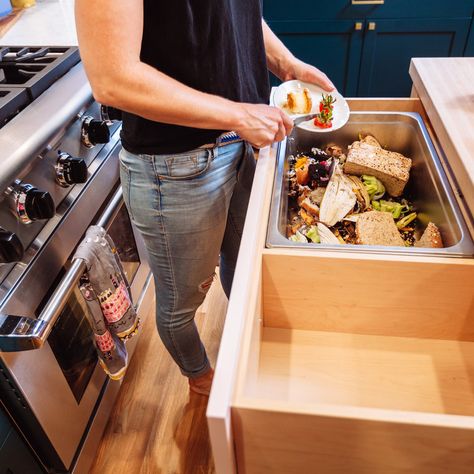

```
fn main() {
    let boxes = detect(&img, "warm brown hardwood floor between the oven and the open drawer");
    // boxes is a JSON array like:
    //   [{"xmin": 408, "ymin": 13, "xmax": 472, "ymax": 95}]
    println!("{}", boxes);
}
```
[{"xmin": 91, "ymin": 281, "xmax": 227, "ymax": 474}]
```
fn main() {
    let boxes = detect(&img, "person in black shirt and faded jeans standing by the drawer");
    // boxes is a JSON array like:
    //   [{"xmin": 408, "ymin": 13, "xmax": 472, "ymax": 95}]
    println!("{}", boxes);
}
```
[{"xmin": 76, "ymin": 0, "xmax": 334, "ymax": 394}]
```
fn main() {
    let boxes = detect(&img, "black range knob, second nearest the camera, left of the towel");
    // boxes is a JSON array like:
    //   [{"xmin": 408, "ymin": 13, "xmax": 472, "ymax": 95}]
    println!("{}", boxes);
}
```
[{"xmin": 12, "ymin": 181, "xmax": 56, "ymax": 224}]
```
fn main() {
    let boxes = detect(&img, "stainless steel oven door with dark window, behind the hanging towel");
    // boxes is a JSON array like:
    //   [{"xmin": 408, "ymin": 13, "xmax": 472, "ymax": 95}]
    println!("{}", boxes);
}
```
[{"xmin": 0, "ymin": 160, "xmax": 150, "ymax": 470}]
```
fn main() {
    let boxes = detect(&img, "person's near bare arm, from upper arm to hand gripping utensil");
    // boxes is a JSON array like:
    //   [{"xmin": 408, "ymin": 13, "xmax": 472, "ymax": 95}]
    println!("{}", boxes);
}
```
[{"xmin": 75, "ymin": 0, "xmax": 292, "ymax": 147}]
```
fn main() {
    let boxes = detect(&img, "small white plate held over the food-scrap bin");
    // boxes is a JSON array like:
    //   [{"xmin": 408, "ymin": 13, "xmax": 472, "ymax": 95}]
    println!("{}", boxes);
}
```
[{"xmin": 273, "ymin": 81, "xmax": 350, "ymax": 133}]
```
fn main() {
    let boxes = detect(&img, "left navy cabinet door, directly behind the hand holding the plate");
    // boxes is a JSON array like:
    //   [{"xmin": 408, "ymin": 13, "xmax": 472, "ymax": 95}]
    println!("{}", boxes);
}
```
[{"xmin": 269, "ymin": 20, "xmax": 364, "ymax": 96}]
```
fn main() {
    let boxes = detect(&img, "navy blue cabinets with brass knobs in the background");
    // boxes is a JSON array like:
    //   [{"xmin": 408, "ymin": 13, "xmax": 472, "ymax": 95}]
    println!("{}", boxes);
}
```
[{"xmin": 264, "ymin": 0, "xmax": 474, "ymax": 97}]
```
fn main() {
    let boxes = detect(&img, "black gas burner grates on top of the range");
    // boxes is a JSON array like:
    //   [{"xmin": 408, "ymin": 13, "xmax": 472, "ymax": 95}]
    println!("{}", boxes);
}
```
[{"xmin": 0, "ymin": 46, "xmax": 80, "ymax": 100}]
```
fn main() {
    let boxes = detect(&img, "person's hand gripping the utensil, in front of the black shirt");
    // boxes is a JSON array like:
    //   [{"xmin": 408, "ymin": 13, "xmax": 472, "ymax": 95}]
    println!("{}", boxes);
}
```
[{"xmin": 234, "ymin": 104, "xmax": 293, "ymax": 148}]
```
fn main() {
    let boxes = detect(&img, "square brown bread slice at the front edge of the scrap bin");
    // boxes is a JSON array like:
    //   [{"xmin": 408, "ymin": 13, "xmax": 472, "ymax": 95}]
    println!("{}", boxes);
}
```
[{"xmin": 356, "ymin": 211, "xmax": 405, "ymax": 247}]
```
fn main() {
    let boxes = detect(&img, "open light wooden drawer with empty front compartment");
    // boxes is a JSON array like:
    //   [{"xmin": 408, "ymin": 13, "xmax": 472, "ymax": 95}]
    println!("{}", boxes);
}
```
[{"xmin": 208, "ymin": 99, "xmax": 474, "ymax": 474}]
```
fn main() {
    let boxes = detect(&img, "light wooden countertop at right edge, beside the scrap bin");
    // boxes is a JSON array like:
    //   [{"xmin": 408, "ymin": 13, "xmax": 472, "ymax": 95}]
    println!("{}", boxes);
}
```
[{"xmin": 410, "ymin": 58, "xmax": 474, "ymax": 215}]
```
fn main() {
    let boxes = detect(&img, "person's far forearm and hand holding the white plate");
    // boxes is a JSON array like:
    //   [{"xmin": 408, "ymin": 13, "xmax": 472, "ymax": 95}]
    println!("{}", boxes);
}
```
[{"xmin": 262, "ymin": 20, "xmax": 335, "ymax": 92}]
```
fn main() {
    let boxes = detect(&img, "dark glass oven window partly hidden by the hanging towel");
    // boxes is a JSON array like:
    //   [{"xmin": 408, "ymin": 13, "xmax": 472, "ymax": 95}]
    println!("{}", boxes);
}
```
[{"xmin": 48, "ymin": 205, "xmax": 140, "ymax": 403}]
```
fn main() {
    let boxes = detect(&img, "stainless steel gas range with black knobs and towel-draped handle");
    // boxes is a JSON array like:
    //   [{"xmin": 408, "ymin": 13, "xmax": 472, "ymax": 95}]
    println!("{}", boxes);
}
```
[{"xmin": 0, "ymin": 47, "xmax": 153, "ymax": 472}]
